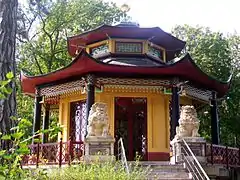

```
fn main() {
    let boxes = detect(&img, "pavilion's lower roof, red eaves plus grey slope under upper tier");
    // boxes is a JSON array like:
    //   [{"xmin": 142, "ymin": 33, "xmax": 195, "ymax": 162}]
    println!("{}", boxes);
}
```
[{"xmin": 21, "ymin": 49, "xmax": 229, "ymax": 97}]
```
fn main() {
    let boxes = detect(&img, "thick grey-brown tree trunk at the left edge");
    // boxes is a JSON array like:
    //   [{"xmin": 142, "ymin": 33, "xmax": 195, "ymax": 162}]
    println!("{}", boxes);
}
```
[{"xmin": 0, "ymin": 0, "xmax": 18, "ymax": 149}]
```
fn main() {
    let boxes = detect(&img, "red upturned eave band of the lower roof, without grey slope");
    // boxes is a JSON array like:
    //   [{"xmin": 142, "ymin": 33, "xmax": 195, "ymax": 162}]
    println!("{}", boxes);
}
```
[{"xmin": 21, "ymin": 50, "xmax": 230, "ymax": 97}]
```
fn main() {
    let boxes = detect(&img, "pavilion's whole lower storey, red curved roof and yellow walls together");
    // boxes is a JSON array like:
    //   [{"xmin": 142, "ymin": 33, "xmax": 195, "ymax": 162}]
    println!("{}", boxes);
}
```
[{"xmin": 21, "ymin": 50, "xmax": 232, "ymax": 164}]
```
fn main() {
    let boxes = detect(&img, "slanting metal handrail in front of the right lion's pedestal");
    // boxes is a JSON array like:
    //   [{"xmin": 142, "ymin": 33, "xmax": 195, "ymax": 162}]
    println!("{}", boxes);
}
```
[{"xmin": 181, "ymin": 139, "xmax": 210, "ymax": 180}]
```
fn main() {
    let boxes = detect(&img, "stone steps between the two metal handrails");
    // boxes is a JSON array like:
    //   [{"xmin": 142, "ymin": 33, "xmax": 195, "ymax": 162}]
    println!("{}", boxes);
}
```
[{"xmin": 129, "ymin": 161, "xmax": 192, "ymax": 180}]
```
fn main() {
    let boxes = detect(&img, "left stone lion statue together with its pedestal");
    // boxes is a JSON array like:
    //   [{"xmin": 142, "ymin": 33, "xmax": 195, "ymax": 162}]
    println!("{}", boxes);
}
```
[{"xmin": 84, "ymin": 102, "xmax": 115, "ymax": 161}]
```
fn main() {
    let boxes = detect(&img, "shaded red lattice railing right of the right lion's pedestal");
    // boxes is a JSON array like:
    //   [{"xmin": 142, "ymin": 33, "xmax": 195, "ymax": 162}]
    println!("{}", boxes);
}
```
[{"xmin": 206, "ymin": 144, "xmax": 240, "ymax": 167}]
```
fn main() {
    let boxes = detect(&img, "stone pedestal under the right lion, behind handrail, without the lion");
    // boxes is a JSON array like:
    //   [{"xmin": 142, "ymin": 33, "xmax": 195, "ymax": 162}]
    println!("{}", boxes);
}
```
[{"xmin": 170, "ymin": 137, "xmax": 206, "ymax": 164}]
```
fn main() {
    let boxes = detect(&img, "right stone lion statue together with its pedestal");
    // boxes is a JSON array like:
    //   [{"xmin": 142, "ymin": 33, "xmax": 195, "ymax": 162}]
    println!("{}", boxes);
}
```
[{"xmin": 170, "ymin": 105, "xmax": 206, "ymax": 164}]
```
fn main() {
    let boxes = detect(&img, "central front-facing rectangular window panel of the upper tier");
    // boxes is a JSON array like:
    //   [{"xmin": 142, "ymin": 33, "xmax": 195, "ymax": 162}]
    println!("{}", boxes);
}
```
[{"xmin": 115, "ymin": 42, "xmax": 142, "ymax": 53}]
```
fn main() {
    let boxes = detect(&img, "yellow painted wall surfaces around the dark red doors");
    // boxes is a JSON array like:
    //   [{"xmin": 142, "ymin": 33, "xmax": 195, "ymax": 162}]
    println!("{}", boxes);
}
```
[{"xmin": 59, "ymin": 90, "xmax": 192, "ymax": 152}]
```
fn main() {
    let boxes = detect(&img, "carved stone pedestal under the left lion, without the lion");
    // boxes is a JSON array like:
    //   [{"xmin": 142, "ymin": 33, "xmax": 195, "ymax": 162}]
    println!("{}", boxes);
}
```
[{"xmin": 84, "ymin": 136, "xmax": 115, "ymax": 161}]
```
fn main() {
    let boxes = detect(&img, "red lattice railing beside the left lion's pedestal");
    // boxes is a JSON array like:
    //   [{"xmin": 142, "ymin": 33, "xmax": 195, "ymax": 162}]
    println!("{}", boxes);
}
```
[{"xmin": 22, "ymin": 140, "xmax": 84, "ymax": 167}]
